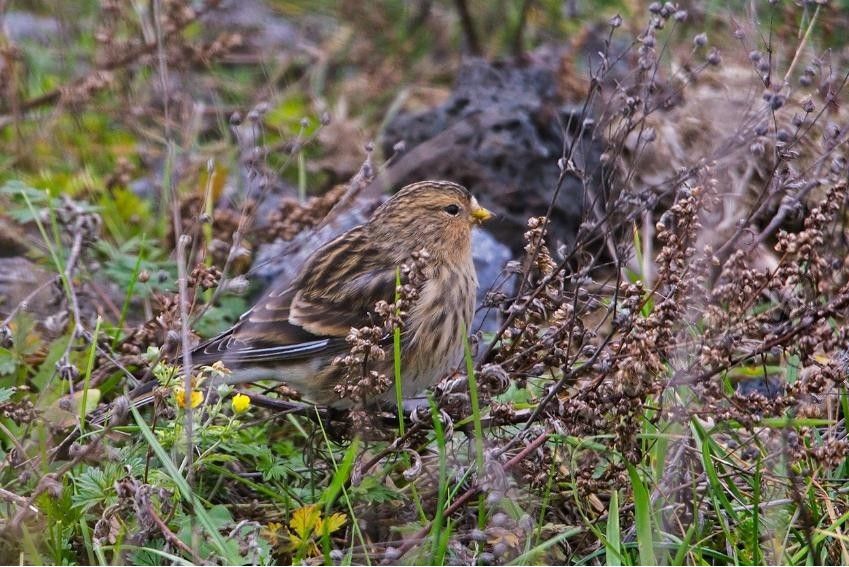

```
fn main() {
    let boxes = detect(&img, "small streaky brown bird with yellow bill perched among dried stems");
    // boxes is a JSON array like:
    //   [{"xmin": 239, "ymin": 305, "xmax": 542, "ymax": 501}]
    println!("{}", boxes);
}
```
[{"xmin": 192, "ymin": 181, "xmax": 492, "ymax": 408}]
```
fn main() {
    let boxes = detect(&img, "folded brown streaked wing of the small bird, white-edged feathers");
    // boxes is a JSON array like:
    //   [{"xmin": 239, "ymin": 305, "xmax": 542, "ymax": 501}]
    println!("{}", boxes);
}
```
[{"xmin": 192, "ymin": 228, "xmax": 396, "ymax": 365}]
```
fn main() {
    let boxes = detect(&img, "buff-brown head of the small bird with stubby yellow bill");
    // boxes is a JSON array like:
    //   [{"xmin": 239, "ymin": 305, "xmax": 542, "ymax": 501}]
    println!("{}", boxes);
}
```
[{"xmin": 369, "ymin": 181, "xmax": 492, "ymax": 257}]
